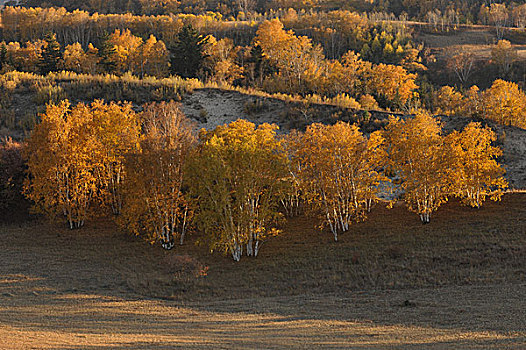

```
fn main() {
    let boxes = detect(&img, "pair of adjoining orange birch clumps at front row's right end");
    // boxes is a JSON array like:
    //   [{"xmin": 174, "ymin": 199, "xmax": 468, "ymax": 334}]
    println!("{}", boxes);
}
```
[{"xmin": 386, "ymin": 112, "xmax": 507, "ymax": 223}]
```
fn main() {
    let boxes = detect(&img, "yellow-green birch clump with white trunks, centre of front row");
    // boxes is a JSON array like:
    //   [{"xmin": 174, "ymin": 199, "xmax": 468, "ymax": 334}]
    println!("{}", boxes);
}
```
[{"xmin": 189, "ymin": 120, "xmax": 289, "ymax": 261}]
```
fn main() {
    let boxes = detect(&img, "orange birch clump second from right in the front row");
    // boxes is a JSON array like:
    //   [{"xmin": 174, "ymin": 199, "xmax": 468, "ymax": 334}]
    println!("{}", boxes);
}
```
[{"xmin": 386, "ymin": 111, "xmax": 450, "ymax": 224}]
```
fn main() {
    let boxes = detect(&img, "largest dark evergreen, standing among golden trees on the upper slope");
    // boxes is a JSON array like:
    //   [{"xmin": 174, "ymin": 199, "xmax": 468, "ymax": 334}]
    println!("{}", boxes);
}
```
[{"xmin": 170, "ymin": 25, "xmax": 208, "ymax": 78}]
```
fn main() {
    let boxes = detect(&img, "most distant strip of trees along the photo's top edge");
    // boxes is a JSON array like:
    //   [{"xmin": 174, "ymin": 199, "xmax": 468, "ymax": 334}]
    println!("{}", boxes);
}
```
[{"xmin": 12, "ymin": 0, "xmax": 524, "ymax": 27}]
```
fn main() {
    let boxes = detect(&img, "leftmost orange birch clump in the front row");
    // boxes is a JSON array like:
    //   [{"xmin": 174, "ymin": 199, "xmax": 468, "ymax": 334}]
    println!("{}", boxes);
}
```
[{"xmin": 25, "ymin": 101, "xmax": 97, "ymax": 229}]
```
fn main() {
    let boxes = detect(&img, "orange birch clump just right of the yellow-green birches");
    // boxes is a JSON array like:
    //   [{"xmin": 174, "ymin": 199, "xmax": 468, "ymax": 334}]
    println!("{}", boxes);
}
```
[{"xmin": 293, "ymin": 122, "xmax": 387, "ymax": 241}]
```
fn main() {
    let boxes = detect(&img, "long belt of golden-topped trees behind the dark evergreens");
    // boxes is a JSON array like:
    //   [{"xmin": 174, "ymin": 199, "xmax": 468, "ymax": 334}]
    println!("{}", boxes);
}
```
[{"xmin": 0, "ymin": 7, "xmax": 426, "ymax": 63}]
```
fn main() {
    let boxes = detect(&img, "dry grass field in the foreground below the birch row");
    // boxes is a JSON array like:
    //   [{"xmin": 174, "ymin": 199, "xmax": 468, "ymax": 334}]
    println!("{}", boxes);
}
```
[{"xmin": 0, "ymin": 194, "xmax": 526, "ymax": 349}]
